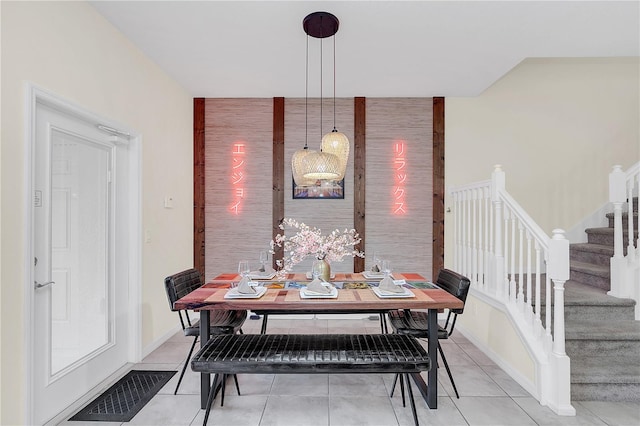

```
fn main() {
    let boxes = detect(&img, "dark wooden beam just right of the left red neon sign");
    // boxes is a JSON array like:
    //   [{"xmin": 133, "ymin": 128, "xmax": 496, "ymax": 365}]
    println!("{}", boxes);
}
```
[{"xmin": 271, "ymin": 98, "xmax": 284, "ymax": 268}]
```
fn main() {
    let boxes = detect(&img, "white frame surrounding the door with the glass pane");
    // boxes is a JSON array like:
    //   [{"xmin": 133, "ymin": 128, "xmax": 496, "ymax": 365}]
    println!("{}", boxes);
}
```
[{"xmin": 23, "ymin": 83, "xmax": 142, "ymax": 424}]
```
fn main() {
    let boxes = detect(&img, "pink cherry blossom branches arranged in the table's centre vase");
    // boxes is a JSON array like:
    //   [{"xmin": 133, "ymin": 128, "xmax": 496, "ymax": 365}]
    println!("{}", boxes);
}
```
[{"xmin": 271, "ymin": 218, "xmax": 364, "ymax": 276}]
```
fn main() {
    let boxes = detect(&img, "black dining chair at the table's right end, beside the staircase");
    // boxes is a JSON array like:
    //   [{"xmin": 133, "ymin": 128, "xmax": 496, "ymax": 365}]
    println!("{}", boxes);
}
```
[{"xmin": 388, "ymin": 269, "xmax": 471, "ymax": 403}]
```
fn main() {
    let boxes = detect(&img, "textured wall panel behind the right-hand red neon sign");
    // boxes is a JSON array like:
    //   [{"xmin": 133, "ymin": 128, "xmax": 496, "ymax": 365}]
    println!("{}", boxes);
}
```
[{"xmin": 365, "ymin": 98, "xmax": 433, "ymax": 279}]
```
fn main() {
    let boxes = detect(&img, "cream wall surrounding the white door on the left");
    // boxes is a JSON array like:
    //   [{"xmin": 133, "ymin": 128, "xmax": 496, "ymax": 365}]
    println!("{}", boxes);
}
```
[{"xmin": 0, "ymin": 2, "xmax": 193, "ymax": 424}]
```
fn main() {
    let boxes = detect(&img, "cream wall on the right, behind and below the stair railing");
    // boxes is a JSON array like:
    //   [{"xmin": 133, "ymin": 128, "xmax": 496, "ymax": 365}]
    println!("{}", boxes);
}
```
[{"xmin": 445, "ymin": 58, "xmax": 640, "ymax": 390}]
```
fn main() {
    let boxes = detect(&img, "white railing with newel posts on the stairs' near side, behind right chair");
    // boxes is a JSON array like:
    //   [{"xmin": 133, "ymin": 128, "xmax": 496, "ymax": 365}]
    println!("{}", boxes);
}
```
[{"xmin": 450, "ymin": 166, "xmax": 575, "ymax": 415}]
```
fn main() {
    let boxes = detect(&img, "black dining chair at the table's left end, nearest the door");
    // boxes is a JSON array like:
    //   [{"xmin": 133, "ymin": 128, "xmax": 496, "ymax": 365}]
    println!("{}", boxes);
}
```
[{"xmin": 164, "ymin": 269, "xmax": 247, "ymax": 395}]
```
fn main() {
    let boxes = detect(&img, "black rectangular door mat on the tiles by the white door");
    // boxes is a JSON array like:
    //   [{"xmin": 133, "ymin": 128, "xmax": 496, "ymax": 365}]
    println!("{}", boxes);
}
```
[{"xmin": 69, "ymin": 370, "xmax": 176, "ymax": 422}]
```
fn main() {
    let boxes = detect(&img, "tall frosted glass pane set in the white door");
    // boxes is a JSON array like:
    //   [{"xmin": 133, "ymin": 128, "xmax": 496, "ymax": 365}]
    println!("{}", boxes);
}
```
[{"xmin": 51, "ymin": 129, "xmax": 111, "ymax": 376}]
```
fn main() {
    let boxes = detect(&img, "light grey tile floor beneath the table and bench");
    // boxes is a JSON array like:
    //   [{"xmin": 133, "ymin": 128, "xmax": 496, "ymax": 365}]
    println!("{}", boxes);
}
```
[{"xmin": 61, "ymin": 317, "xmax": 640, "ymax": 426}]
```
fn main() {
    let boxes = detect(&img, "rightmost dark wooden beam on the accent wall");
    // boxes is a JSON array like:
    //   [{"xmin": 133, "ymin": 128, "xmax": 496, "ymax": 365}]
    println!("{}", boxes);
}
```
[{"xmin": 432, "ymin": 97, "xmax": 445, "ymax": 277}]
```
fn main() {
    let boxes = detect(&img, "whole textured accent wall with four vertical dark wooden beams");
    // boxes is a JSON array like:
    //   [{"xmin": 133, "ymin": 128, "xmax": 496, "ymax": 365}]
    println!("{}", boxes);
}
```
[{"xmin": 198, "ymin": 97, "xmax": 444, "ymax": 279}]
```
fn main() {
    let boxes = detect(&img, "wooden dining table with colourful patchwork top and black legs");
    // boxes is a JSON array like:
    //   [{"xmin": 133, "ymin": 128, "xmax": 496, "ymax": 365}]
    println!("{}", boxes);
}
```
[{"xmin": 174, "ymin": 272, "xmax": 464, "ymax": 409}]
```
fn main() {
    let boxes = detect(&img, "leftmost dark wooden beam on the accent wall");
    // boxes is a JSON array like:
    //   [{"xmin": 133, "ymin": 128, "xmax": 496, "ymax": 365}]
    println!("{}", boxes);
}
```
[{"xmin": 193, "ymin": 98, "xmax": 205, "ymax": 279}]
